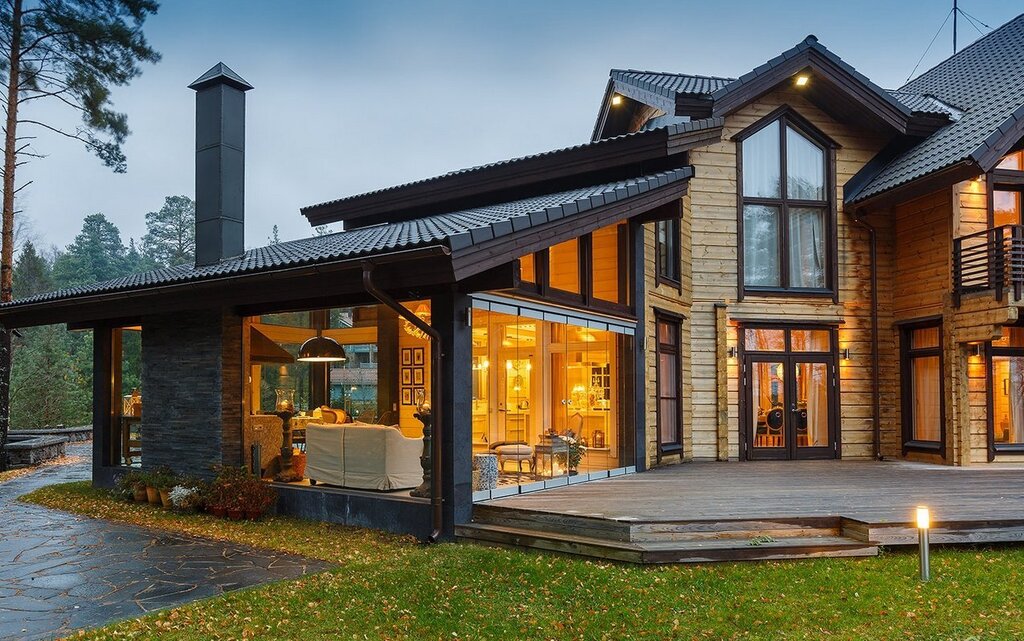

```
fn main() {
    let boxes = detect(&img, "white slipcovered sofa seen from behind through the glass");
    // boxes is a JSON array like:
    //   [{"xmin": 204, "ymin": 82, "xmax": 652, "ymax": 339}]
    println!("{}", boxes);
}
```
[{"xmin": 306, "ymin": 423, "xmax": 423, "ymax": 492}]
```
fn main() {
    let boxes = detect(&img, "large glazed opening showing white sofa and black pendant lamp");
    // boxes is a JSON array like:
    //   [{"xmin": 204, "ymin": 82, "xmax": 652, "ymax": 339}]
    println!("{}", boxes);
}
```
[{"xmin": 245, "ymin": 301, "xmax": 431, "ymax": 495}]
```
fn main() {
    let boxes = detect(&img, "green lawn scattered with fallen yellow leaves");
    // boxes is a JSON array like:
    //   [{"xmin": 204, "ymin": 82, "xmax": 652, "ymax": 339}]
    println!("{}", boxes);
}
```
[{"xmin": 24, "ymin": 483, "xmax": 1024, "ymax": 641}]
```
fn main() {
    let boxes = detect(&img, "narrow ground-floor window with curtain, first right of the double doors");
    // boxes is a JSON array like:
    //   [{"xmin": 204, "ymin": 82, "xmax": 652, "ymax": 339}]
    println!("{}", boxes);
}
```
[{"xmin": 900, "ymin": 323, "xmax": 945, "ymax": 453}]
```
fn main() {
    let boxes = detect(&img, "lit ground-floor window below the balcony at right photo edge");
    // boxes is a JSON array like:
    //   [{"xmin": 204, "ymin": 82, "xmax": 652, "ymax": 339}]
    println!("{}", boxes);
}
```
[{"xmin": 988, "ymin": 327, "xmax": 1024, "ymax": 453}]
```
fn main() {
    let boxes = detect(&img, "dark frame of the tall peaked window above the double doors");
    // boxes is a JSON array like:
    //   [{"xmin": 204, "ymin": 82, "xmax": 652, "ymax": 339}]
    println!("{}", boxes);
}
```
[{"xmin": 732, "ymin": 105, "xmax": 841, "ymax": 303}]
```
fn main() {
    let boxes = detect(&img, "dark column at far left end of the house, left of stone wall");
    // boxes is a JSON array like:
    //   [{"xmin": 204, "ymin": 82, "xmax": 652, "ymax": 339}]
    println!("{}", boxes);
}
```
[{"xmin": 92, "ymin": 327, "xmax": 121, "ymax": 486}]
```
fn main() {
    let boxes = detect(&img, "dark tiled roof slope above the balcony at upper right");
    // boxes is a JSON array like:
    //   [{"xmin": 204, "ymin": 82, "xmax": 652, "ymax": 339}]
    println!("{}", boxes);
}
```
[{"xmin": 853, "ymin": 15, "xmax": 1024, "ymax": 201}]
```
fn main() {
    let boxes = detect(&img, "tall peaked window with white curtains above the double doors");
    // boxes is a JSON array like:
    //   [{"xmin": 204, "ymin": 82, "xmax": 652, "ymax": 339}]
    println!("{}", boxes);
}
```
[{"xmin": 737, "ymin": 112, "xmax": 835, "ymax": 294}]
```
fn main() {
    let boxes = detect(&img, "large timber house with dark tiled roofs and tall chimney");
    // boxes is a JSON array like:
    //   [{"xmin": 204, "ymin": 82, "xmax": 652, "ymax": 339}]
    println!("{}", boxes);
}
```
[{"xmin": 0, "ymin": 16, "xmax": 1024, "ymax": 538}]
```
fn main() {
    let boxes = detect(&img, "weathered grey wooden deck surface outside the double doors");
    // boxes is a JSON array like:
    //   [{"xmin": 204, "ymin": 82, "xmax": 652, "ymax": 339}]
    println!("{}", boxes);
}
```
[{"xmin": 483, "ymin": 461, "xmax": 1024, "ymax": 523}]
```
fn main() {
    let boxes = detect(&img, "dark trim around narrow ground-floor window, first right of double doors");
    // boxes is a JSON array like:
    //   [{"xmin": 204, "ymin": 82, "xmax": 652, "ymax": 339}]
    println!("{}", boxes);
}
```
[{"xmin": 899, "ymin": 317, "xmax": 946, "ymax": 459}]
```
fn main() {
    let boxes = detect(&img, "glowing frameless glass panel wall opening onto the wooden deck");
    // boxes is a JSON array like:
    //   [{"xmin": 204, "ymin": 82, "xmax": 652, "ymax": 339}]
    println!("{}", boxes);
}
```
[{"xmin": 472, "ymin": 304, "xmax": 633, "ymax": 490}]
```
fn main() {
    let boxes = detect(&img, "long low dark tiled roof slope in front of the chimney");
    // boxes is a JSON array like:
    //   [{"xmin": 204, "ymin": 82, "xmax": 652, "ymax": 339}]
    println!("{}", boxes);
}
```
[{"xmin": 0, "ymin": 167, "xmax": 692, "ymax": 311}]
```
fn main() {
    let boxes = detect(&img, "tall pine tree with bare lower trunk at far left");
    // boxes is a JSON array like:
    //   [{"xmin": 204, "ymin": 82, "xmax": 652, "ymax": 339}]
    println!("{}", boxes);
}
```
[{"xmin": 0, "ymin": 0, "xmax": 160, "ymax": 470}]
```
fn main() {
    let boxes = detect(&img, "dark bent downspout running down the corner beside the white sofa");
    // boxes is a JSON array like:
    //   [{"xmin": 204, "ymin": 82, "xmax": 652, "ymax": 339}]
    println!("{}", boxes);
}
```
[{"xmin": 362, "ymin": 261, "xmax": 444, "ymax": 543}]
